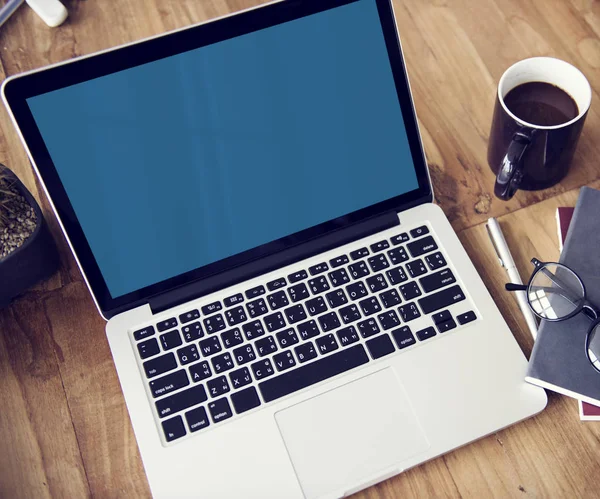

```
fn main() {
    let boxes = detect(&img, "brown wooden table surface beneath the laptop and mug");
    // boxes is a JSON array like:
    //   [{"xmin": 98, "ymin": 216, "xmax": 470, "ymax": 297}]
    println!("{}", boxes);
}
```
[{"xmin": 0, "ymin": 0, "xmax": 600, "ymax": 498}]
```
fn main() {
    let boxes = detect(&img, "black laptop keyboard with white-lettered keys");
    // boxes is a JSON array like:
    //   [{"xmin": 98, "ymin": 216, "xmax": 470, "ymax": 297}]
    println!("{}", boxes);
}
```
[{"xmin": 132, "ymin": 225, "xmax": 476, "ymax": 442}]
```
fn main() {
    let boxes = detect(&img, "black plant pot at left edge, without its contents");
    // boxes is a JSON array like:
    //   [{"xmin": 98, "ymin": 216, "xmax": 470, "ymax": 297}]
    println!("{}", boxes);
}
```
[{"xmin": 0, "ymin": 165, "xmax": 59, "ymax": 309}]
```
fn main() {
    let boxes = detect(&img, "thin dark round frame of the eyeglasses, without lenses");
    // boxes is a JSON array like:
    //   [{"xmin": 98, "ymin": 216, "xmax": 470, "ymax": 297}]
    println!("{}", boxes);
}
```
[{"xmin": 504, "ymin": 258, "xmax": 600, "ymax": 373}]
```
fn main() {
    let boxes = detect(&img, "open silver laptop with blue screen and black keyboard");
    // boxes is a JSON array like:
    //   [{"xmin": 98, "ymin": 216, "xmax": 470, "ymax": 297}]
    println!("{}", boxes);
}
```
[{"xmin": 3, "ymin": 0, "xmax": 546, "ymax": 498}]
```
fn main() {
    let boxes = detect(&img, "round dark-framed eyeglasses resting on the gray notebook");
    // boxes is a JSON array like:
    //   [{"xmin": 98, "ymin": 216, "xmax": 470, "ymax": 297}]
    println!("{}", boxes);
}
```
[{"xmin": 506, "ymin": 258, "xmax": 600, "ymax": 373}]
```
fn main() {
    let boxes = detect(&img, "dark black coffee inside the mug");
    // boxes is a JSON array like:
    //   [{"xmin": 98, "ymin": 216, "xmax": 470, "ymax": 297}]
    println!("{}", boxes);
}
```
[{"xmin": 504, "ymin": 81, "xmax": 579, "ymax": 126}]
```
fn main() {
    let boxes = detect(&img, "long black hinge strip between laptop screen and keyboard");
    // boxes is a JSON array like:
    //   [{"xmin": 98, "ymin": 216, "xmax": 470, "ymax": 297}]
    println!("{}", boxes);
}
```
[{"xmin": 148, "ymin": 211, "xmax": 400, "ymax": 314}]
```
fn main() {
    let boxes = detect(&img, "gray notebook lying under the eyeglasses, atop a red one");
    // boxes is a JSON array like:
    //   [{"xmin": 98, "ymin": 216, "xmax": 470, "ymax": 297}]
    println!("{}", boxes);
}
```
[{"xmin": 525, "ymin": 187, "xmax": 600, "ymax": 405}]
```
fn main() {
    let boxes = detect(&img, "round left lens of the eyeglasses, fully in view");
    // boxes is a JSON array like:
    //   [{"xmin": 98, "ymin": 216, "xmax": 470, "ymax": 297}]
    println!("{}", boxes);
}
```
[{"xmin": 527, "ymin": 263, "xmax": 585, "ymax": 320}]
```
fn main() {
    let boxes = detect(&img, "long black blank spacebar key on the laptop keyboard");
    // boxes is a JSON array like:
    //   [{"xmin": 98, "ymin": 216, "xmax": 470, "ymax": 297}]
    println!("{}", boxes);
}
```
[{"xmin": 258, "ymin": 345, "xmax": 369, "ymax": 402}]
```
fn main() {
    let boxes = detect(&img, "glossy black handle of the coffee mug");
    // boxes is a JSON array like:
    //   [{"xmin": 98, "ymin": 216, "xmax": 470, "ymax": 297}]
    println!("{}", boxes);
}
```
[{"xmin": 494, "ymin": 128, "xmax": 535, "ymax": 201}]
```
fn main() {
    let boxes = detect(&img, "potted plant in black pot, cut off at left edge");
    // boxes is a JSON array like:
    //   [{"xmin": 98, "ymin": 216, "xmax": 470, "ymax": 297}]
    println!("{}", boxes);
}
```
[{"xmin": 0, "ymin": 164, "xmax": 59, "ymax": 308}]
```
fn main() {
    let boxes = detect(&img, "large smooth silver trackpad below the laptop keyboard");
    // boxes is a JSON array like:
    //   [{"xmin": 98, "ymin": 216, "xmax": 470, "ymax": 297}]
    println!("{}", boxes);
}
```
[{"xmin": 275, "ymin": 368, "xmax": 429, "ymax": 499}]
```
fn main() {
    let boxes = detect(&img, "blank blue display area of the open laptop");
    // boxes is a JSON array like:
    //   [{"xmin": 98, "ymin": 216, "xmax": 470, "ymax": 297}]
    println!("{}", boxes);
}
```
[{"xmin": 27, "ymin": 0, "xmax": 418, "ymax": 298}]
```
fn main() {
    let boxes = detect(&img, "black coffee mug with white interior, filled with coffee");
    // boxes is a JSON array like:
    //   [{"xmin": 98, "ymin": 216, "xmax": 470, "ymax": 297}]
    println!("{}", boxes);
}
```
[{"xmin": 488, "ymin": 57, "xmax": 592, "ymax": 200}]
